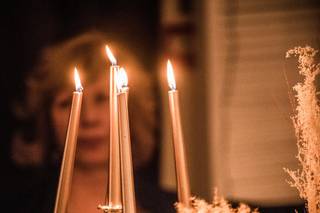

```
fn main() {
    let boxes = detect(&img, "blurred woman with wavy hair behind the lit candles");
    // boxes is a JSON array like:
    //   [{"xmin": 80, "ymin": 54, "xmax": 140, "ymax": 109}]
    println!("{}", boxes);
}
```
[{"xmin": 9, "ymin": 32, "xmax": 175, "ymax": 213}]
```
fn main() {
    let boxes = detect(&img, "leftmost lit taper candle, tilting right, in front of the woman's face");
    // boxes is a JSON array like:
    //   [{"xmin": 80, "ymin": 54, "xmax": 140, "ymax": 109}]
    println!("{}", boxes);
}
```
[{"xmin": 54, "ymin": 68, "xmax": 83, "ymax": 213}]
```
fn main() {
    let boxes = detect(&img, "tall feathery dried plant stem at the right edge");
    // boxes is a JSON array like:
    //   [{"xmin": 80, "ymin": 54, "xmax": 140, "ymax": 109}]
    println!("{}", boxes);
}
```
[{"xmin": 285, "ymin": 46, "xmax": 320, "ymax": 213}]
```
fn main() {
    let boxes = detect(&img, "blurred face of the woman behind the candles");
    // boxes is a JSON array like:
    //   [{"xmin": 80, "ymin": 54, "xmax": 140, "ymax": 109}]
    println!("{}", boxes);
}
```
[{"xmin": 51, "ymin": 75, "xmax": 109, "ymax": 166}]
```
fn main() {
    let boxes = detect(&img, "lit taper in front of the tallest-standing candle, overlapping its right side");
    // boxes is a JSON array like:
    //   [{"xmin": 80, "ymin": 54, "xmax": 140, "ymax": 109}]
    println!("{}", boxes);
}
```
[{"xmin": 116, "ymin": 68, "xmax": 136, "ymax": 213}]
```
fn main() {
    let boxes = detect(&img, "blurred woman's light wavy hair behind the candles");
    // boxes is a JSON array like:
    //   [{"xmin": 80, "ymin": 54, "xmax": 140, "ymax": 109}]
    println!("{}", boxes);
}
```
[{"xmin": 13, "ymin": 32, "xmax": 158, "ymax": 170}]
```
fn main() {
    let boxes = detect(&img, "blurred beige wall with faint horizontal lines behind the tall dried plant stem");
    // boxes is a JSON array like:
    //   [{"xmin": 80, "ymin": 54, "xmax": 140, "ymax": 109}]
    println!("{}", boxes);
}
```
[{"xmin": 203, "ymin": 0, "xmax": 320, "ymax": 205}]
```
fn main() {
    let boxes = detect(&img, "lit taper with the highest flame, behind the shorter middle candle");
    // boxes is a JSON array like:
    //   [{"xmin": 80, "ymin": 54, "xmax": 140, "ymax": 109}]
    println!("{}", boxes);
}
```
[{"xmin": 106, "ymin": 46, "xmax": 122, "ymax": 209}]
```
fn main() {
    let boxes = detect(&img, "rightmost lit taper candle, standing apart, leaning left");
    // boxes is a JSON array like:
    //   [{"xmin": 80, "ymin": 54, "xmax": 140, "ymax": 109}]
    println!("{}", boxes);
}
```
[{"xmin": 167, "ymin": 60, "xmax": 190, "ymax": 207}]
